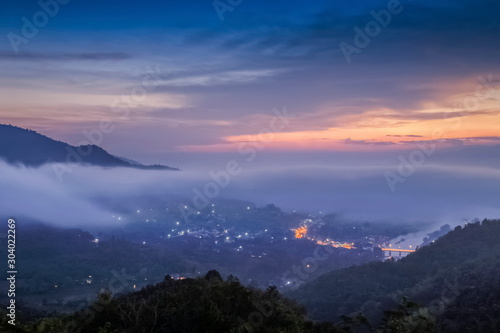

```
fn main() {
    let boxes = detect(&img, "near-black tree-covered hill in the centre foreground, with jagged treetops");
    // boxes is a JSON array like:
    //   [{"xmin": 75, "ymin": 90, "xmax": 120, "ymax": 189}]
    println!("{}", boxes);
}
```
[{"xmin": 0, "ymin": 270, "xmax": 344, "ymax": 333}]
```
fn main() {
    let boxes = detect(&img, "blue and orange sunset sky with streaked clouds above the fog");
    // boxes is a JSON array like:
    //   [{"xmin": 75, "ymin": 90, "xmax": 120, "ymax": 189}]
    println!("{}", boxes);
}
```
[{"xmin": 0, "ymin": 0, "xmax": 500, "ymax": 164}]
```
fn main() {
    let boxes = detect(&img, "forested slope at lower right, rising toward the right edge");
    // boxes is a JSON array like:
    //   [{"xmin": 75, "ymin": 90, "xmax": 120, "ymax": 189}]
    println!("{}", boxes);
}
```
[{"xmin": 291, "ymin": 220, "xmax": 500, "ymax": 332}]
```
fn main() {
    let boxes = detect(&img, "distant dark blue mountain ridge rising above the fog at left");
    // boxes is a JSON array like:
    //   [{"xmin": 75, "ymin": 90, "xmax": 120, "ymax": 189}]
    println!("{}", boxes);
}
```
[{"xmin": 0, "ymin": 124, "xmax": 178, "ymax": 170}]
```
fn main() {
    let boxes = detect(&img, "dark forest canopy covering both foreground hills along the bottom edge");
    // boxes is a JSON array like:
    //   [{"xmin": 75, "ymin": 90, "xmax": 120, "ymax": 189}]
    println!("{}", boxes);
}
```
[{"xmin": 0, "ymin": 220, "xmax": 500, "ymax": 333}]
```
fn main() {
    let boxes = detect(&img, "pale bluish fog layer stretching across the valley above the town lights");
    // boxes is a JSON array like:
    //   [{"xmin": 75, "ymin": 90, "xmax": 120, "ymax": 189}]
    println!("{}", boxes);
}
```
[{"xmin": 0, "ymin": 146, "xmax": 500, "ymax": 226}]
